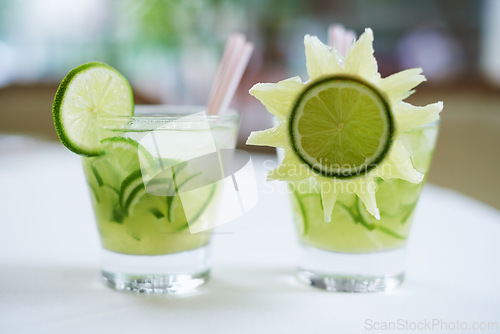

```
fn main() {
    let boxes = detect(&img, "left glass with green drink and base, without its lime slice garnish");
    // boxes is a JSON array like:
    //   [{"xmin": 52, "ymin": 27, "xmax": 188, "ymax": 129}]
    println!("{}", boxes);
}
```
[{"xmin": 83, "ymin": 106, "xmax": 239, "ymax": 293}]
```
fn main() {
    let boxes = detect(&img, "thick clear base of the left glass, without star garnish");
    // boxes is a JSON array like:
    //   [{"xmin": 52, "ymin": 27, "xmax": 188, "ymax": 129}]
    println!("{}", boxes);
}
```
[{"xmin": 101, "ymin": 245, "xmax": 210, "ymax": 293}]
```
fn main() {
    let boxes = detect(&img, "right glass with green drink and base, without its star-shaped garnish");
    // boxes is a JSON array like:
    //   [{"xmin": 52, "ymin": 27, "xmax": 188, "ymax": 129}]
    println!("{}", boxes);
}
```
[{"xmin": 288, "ymin": 122, "xmax": 438, "ymax": 292}]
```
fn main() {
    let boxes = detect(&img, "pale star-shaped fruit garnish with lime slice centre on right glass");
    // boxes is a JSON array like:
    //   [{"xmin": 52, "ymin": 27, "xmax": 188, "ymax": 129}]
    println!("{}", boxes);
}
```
[{"xmin": 247, "ymin": 29, "xmax": 443, "ymax": 220}]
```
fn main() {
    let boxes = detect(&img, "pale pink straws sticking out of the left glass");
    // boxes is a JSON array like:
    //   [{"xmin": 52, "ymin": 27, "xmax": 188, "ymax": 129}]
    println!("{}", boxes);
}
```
[{"xmin": 207, "ymin": 33, "xmax": 254, "ymax": 115}]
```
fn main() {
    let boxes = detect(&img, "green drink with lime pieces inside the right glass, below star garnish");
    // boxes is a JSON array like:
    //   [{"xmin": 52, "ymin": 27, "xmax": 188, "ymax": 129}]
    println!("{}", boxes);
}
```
[{"xmin": 289, "ymin": 125, "xmax": 437, "ymax": 253}]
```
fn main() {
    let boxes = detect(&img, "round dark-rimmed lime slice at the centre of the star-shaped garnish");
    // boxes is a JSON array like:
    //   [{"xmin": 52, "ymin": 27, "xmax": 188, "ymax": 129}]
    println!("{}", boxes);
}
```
[{"xmin": 289, "ymin": 76, "xmax": 394, "ymax": 178}]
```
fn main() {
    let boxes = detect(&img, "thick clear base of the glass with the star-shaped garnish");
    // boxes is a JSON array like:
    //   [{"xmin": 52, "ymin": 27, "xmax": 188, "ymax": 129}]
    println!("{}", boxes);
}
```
[{"xmin": 297, "ymin": 246, "xmax": 405, "ymax": 292}]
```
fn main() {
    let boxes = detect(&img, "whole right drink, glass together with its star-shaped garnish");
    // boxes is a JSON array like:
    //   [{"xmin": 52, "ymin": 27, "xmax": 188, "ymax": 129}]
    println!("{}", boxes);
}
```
[{"xmin": 248, "ymin": 29, "xmax": 442, "ymax": 292}]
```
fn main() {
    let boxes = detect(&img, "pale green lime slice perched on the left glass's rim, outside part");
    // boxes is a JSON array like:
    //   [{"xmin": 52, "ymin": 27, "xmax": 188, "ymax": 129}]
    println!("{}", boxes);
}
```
[{"xmin": 52, "ymin": 62, "xmax": 134, "ymax": 156}]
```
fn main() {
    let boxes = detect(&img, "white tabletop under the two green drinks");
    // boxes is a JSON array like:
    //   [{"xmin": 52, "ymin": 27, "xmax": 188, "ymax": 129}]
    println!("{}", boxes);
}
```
[{"xmin": 0, "ymin": 137, "xmax": 500, "ymax": 334}]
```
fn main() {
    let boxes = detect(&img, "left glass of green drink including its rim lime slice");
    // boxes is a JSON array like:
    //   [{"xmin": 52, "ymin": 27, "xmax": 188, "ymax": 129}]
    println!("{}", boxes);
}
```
[{"xmin": 53, "ymin": 62, "xmax": 239, "ymax": 293}]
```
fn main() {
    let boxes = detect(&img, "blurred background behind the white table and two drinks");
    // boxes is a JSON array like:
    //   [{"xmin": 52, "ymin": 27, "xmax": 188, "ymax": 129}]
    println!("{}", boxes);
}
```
[{"xmin": 0, "ymin": 0, "xmax": 500, "ymax": 208}]
